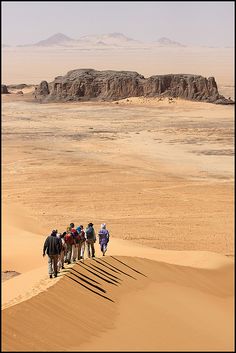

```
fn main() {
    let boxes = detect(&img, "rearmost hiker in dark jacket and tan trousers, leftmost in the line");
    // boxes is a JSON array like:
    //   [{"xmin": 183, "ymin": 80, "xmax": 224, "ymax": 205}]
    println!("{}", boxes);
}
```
[{"xmin": 43, "ymin": 230, "xmax": 62, "ymax": 278}]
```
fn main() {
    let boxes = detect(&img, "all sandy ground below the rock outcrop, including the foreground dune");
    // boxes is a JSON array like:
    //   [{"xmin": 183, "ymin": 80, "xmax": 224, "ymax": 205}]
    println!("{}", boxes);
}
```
[{"xmin": 2, "ymin": 92, "xmax": 234, "ymax": 351}]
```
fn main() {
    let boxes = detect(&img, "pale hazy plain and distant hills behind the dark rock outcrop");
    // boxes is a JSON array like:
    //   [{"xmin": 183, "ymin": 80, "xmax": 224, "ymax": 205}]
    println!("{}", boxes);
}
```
[{"xmin": 2, "ymin": 33, "xmax": 234, "ymax": 97}]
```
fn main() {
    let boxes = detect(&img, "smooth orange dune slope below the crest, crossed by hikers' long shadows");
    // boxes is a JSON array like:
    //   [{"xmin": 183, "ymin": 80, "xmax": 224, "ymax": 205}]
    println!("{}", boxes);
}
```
[{"xmin": 2, "ymin": 256, "xmax": 233, "ymax": 351}]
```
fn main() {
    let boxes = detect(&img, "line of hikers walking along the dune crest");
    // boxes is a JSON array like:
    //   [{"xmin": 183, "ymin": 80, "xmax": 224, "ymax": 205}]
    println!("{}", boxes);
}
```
[{"xmin": 43, "ymin": 223, "xmax": 110, "ymax": 278}]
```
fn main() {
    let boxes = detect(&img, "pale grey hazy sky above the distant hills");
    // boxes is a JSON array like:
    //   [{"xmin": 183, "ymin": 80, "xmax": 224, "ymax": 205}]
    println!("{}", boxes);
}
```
[{"xmin": 1, "ymin": 1, "xmax": 234, "ymax": 46}]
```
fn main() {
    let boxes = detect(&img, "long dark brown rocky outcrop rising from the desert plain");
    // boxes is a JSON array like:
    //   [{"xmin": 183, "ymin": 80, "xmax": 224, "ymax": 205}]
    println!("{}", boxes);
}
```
[{"xmin": 35, "ymin": 69, "xmax": 234, "ymax": 104}]
